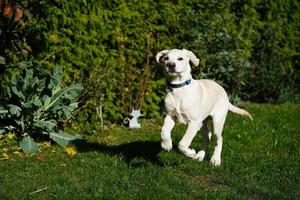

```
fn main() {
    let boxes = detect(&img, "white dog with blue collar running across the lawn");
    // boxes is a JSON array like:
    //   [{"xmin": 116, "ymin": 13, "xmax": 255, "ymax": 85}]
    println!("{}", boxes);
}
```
[{"xmin": 156, "ymin": 49, "xmax": 252, "ymax": 166}]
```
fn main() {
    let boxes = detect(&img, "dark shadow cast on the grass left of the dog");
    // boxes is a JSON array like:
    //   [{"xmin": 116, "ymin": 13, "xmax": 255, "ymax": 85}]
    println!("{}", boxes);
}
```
[{"xmin": 76, "ymin": 141, "xmax": 164, "ymax": 167}]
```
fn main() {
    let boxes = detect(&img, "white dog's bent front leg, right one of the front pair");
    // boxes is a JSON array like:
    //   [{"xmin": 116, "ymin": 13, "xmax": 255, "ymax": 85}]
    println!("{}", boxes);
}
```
[{"xmin": 178, "ymin": 121, "xmax": 202, "ymax": 158}]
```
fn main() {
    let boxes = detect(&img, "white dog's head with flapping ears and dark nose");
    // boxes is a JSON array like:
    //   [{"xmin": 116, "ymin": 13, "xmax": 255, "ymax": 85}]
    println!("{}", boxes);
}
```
[{"xmin": 156, "ymin": 49, "xmax": 199, "ymax": 76}]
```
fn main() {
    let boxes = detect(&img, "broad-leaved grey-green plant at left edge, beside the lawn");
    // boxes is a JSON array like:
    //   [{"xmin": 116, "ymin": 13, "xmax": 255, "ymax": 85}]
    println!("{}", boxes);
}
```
[{"xmin": 0, "ymin": 61, "xmax": 83, "ymax": 153}]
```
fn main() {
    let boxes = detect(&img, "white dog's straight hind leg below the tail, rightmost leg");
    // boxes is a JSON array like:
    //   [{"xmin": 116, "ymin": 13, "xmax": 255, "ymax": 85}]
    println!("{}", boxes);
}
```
[{"xmin": 210, "ymin": 112, "xmax": 227, "ymax": 166}]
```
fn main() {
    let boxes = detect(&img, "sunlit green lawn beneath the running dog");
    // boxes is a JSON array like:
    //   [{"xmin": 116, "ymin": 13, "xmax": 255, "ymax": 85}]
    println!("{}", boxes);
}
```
[{"xmin": 0, "ymin": 104, "xmax": 300, "ymax": 200}]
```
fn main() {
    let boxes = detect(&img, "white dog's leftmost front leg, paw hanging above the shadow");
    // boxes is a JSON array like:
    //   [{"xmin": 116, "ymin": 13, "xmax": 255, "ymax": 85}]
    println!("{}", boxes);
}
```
[{"xmin": 161, "ymin": 115, "xmax": 175, "ymax": 151}]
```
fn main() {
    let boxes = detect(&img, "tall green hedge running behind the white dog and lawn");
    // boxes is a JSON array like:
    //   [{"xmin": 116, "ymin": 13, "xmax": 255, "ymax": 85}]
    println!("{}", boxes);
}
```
[{"xmin": 1, "ymin": 0, "xmax": 300, "ymax": 123}]
